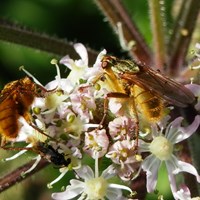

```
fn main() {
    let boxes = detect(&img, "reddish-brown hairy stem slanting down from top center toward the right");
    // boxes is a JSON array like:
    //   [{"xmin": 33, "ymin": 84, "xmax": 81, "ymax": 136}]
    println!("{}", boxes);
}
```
[{"xmin": 96, "ymin": 0, "xmax": 152, "ymax": 65}]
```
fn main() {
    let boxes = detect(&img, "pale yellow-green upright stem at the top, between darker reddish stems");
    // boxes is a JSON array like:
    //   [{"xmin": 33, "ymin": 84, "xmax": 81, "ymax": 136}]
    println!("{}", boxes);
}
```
[{"xmin": 148, "ymin": 0, "xmax": 166, "ymax": 70}]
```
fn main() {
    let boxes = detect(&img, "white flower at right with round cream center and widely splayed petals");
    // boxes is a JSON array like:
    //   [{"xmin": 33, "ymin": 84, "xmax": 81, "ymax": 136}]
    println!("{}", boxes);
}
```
[{"xmin": 139, "ymin": 115, "xmax": 200, "ymax": 198}]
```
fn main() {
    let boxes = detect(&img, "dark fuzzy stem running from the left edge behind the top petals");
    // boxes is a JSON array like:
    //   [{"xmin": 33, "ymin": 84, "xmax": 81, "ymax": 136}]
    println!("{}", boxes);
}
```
[{"xmin": 0, "ymin": 19, "xmax": 97, "ymax": 64}]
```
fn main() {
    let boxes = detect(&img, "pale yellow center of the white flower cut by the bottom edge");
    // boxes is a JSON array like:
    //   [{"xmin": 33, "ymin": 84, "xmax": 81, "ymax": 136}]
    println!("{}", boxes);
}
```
[{"xmin": 84, "ymin": 177, "xmax": 108, "ymax": 200}]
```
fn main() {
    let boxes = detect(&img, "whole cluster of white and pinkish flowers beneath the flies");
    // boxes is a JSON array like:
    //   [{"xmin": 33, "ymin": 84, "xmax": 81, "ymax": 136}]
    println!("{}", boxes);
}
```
[{"xmin": 2, "ymin": 44, "xmax": 200, "ymax": 200}]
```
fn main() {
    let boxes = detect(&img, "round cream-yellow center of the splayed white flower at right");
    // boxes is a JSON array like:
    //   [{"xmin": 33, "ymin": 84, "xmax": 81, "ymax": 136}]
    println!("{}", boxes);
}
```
[{"xmin": 149, "ymin": 136, "xmax": 173, "ymax": 160}]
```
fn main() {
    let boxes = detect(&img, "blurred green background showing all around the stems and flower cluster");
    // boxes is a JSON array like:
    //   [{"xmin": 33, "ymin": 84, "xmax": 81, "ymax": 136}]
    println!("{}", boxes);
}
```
[{"xmin": 0, "ymin": 0, "xmax": 198, "ymax": 200}]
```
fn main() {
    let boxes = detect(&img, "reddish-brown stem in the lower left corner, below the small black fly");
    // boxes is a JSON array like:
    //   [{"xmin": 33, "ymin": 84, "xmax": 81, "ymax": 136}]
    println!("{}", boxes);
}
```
[{"xmin": 0, "ymin": 160, "xmax": 49, "ymax": 193}]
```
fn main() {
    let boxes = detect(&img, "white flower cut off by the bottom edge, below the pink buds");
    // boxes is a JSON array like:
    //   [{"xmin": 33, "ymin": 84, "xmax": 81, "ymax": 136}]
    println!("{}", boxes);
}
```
[{"xmin": 52, "ymin": 153, "xmax": 132, "ymax": 200}]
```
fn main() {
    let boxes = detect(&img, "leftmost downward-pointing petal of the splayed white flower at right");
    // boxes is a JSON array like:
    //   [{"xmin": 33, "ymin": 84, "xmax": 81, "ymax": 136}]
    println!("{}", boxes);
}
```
[{"xmin": 142, "ymin": 155, "xmax": 161, "ymax": 192}]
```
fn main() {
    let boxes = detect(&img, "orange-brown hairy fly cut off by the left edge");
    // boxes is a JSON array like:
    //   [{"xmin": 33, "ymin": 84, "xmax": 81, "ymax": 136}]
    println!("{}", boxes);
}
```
[{"xmin": 0, "ymin": 76, "xmax": 49, "ymax": 143}]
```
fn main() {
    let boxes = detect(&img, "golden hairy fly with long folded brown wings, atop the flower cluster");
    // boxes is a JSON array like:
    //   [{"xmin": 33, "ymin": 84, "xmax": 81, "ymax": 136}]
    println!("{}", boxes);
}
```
[{"xmin": 102, "ymin": 56, "xmax": 196, "ymax": 125}]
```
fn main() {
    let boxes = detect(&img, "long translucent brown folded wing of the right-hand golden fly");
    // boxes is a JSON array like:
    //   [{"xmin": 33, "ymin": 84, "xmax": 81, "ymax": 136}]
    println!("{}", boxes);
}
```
[{"xmin": 120, "ymin": 65, "xmax": 196, "ymax": 107}]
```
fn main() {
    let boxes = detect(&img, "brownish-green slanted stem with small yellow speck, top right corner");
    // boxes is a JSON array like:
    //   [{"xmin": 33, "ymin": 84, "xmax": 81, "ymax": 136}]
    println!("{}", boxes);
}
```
[{"xmin": 168, "ymin": 0, "xmax": 200, "ymax": 77}]
